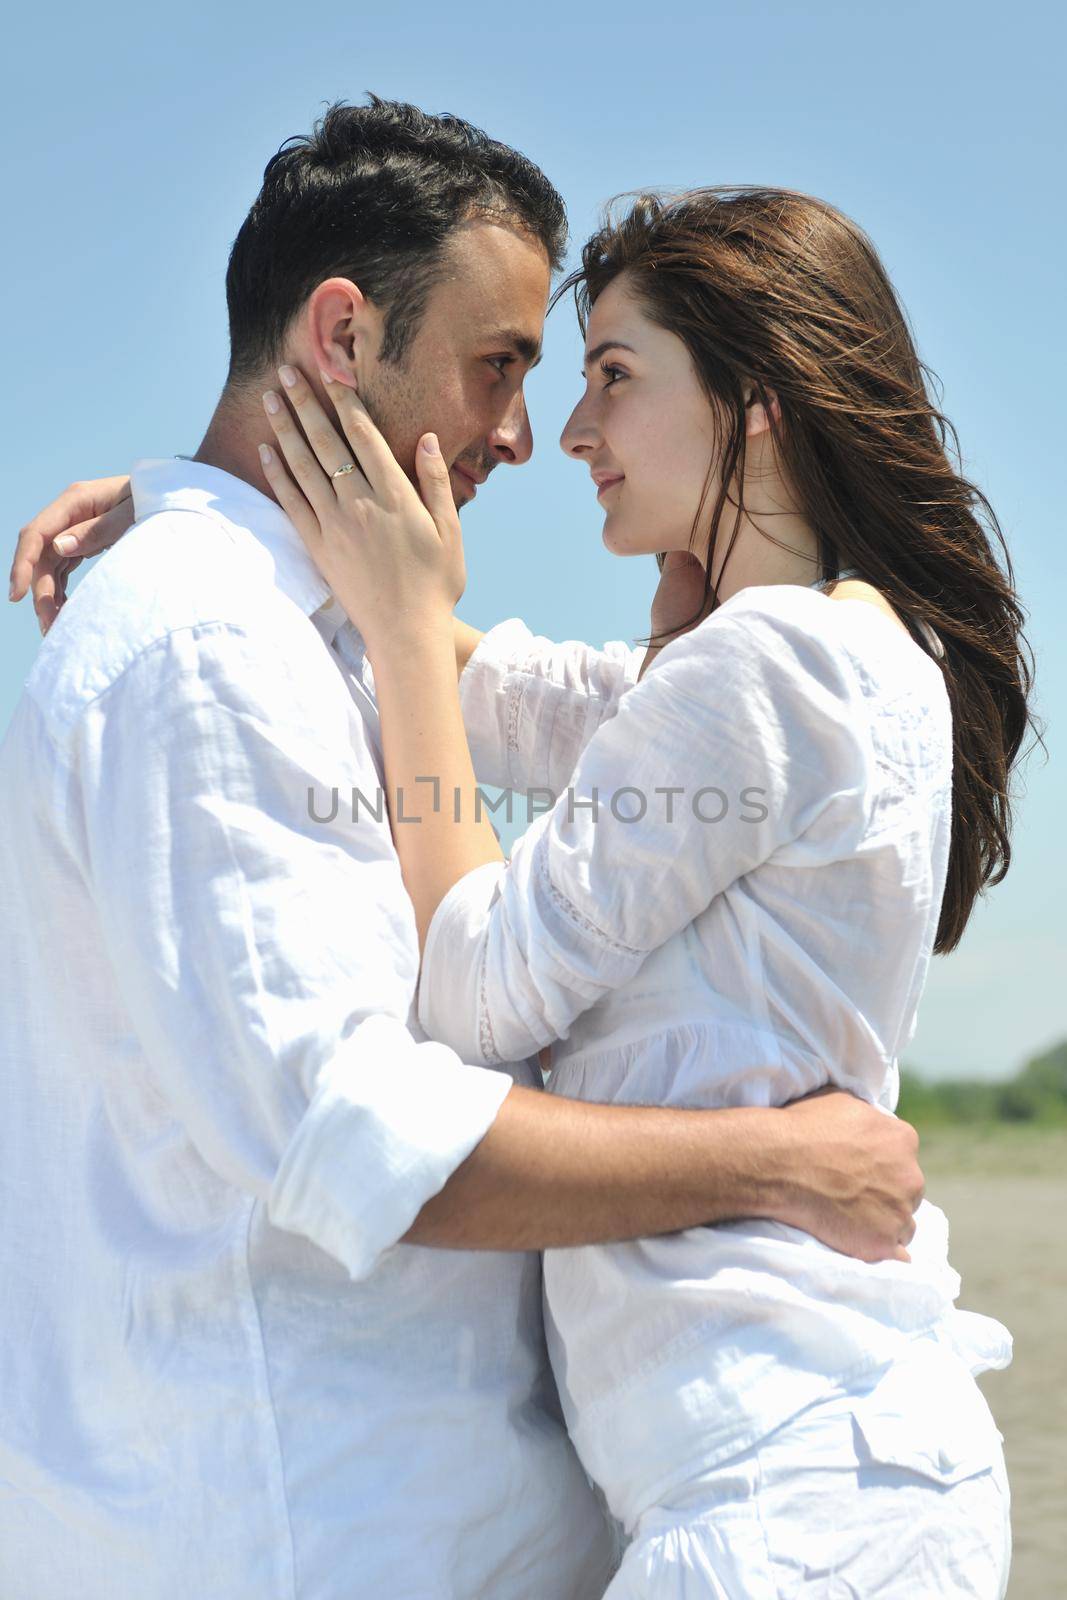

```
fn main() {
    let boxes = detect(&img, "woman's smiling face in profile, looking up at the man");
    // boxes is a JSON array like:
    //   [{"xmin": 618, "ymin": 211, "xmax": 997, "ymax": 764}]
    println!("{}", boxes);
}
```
[{"xmin": 560, "ymin": 275, "xmax": 718, "ymax": 562}]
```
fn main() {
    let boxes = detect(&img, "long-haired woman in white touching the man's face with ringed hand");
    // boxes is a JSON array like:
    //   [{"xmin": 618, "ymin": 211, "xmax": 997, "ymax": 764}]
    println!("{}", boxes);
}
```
[{"xmin": 251, "ymin": 189, "xmax": 1030, "ymax": 1597}]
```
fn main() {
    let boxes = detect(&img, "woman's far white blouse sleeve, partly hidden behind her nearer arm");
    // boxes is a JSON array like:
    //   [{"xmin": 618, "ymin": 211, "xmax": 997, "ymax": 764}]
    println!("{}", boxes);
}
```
[{"xmin": 459, "ymin": 618, "xmax": 643, "ymax": 798}]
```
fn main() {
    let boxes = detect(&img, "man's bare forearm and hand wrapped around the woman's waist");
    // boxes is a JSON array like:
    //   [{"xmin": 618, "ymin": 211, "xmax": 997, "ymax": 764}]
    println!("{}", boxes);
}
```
[{"xmin": 405, "ymin": 1085, "xmax": 923, "ymax": 1261}]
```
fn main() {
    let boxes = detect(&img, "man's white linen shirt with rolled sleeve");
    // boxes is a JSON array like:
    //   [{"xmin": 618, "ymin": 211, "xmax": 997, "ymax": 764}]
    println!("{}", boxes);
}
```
[{"xmin": 0, "ymin": 461, "xmax": 613, "ymax": 1600}]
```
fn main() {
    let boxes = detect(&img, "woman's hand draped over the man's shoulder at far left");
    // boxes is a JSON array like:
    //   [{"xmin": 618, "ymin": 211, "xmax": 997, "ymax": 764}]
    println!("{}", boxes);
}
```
[{"xmin": 8, "ymin": 478, "xmax": 134, "ymax": 634}]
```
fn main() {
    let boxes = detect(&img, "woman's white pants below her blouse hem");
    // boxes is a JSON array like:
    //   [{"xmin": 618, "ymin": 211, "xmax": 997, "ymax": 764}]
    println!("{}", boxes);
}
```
[{"xmin": 605, "ymin": 1349, "xmax": 1011, "ymax": 1600}]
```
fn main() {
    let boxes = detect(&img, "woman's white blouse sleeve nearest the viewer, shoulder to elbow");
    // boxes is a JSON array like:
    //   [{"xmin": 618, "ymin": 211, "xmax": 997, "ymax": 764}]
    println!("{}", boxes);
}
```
[{"xmin": 419, "ymin": 602, "xmax": 872, "ymax": 1064}]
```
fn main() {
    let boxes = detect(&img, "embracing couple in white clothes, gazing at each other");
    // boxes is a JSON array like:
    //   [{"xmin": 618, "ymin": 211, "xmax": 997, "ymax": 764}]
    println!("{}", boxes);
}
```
[{"xmin": 0, "ymin": 98, "xmax": 1030, "ymax": 1600}]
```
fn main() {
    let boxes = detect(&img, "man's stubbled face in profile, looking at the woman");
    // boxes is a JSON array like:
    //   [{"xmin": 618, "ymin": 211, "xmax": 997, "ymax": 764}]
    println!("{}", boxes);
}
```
[{"xmin": 358, "ymin": 221, "xmax": 550, "ymax": 506}]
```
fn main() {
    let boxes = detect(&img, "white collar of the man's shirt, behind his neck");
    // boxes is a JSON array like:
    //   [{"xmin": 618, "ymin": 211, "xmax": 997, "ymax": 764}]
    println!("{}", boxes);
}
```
[{"xmin": 130, "ymin": 456, "xmax": 347, "ymax": 638}]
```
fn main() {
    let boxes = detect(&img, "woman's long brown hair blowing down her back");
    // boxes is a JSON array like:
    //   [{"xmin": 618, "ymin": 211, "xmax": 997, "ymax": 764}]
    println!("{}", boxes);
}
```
[{"xmin": 555, "ymin": 186, "xmax": 1040, "ymax": 954}]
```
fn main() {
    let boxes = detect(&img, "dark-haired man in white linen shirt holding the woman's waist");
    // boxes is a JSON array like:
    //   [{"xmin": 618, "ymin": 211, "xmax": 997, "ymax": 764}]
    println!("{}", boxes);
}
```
[{"xmin": 0, "ymin": 99, "xmax": 921, "ymax": 1600}]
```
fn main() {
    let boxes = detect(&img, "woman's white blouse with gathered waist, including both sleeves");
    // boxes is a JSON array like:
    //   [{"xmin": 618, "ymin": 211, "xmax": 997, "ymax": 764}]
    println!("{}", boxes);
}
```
[{"xmin": 419, "ymin": 584, "xmax": 1009, "ymax": 1520}]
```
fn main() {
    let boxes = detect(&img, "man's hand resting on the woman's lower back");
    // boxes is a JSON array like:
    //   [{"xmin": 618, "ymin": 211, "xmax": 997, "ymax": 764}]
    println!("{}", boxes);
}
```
[{"xmin": 773, "ymin": 1090, "xmax": 925, "ymax": 1261}]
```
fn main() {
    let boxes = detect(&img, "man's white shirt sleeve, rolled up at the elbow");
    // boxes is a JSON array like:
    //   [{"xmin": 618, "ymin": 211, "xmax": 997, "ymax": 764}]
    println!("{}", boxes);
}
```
[{"xmin": 72, "ymin": 624, "xmax": 512, "ymax": 1278}]
